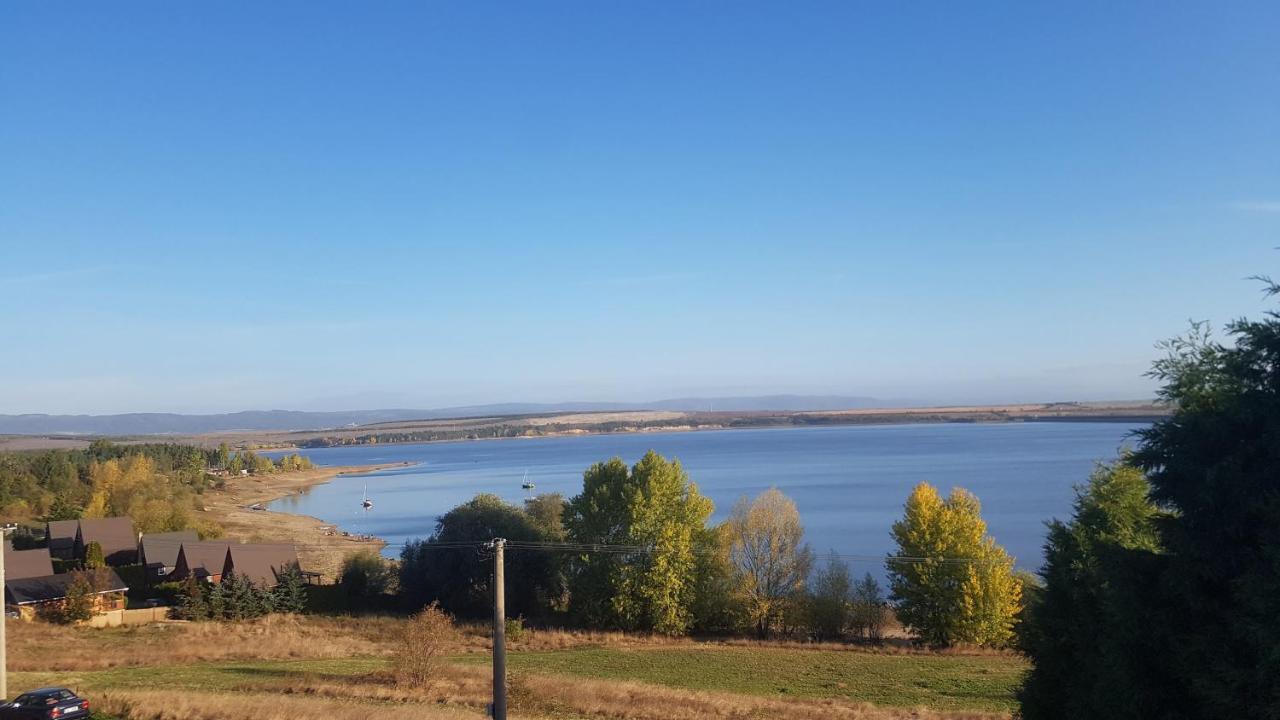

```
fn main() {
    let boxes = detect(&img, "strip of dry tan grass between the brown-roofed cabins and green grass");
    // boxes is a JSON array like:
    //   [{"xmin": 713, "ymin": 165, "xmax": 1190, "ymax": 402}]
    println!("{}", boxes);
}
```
[{"xmin": 8, "ymin": 615, "xmax": 403, "ymax": 670}]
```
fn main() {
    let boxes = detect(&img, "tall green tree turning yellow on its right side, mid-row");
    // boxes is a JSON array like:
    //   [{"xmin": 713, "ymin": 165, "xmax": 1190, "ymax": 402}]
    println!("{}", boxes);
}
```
[{"xmin": 564, "ymin": 451, "xmax": 713, "ymax": 634}]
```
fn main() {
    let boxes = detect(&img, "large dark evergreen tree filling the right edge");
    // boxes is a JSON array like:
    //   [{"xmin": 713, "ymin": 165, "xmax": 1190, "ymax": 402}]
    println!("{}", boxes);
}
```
[{"xmin": 1024, "ymin": 299, "xmax": 1280, "ymax": 720}]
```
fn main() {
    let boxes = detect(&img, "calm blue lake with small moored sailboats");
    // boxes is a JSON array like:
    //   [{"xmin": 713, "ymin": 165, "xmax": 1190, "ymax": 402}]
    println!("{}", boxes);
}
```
[{"xmin": 270, "ymin": 423, "xmax": 1146, "ymax": 573}]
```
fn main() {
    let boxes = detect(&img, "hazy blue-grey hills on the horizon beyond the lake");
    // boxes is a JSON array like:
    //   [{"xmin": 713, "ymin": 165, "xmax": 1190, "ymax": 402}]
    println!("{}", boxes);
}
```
[{"xmin": 0, "ymin": 395, "xmax": 879, "ymax": 436}]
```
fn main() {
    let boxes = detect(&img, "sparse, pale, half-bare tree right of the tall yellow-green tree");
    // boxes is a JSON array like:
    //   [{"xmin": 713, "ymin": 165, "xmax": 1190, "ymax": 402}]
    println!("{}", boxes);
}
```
[{"xmin": 727, "ymin": 488, "xmax": 813, "ymax": 638}]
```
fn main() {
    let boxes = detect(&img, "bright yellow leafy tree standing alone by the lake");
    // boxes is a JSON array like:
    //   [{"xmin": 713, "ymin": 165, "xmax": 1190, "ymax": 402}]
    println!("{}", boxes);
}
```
[{"xmin": 888, "ymin": 483, "xmax": 1021, "ymax": 647}]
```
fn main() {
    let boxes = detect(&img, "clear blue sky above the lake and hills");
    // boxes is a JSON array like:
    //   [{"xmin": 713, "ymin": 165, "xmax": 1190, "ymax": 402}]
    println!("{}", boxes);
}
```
[{"xmin": 0, "ymin": 1, "xmax": 1280, "ymax": 413}]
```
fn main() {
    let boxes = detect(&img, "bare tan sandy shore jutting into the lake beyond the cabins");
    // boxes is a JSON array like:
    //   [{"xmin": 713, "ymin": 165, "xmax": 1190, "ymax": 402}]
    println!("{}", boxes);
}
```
[{"xmin": 202, "ymin": 462, "xmax": 407, "ymax": 583}]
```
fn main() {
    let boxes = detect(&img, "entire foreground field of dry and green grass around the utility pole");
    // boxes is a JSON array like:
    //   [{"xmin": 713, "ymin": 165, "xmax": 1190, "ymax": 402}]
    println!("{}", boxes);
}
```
[{"xmin": 9, "ymin": 616, "xmax": 1025, "ymax": 720}]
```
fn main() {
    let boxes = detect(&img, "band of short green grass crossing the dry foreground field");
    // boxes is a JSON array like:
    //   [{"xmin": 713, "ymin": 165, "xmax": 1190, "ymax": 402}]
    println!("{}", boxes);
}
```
[{"xmin": 9, "ymin": 646, "xmax": 1027, "ymax": 712}]
